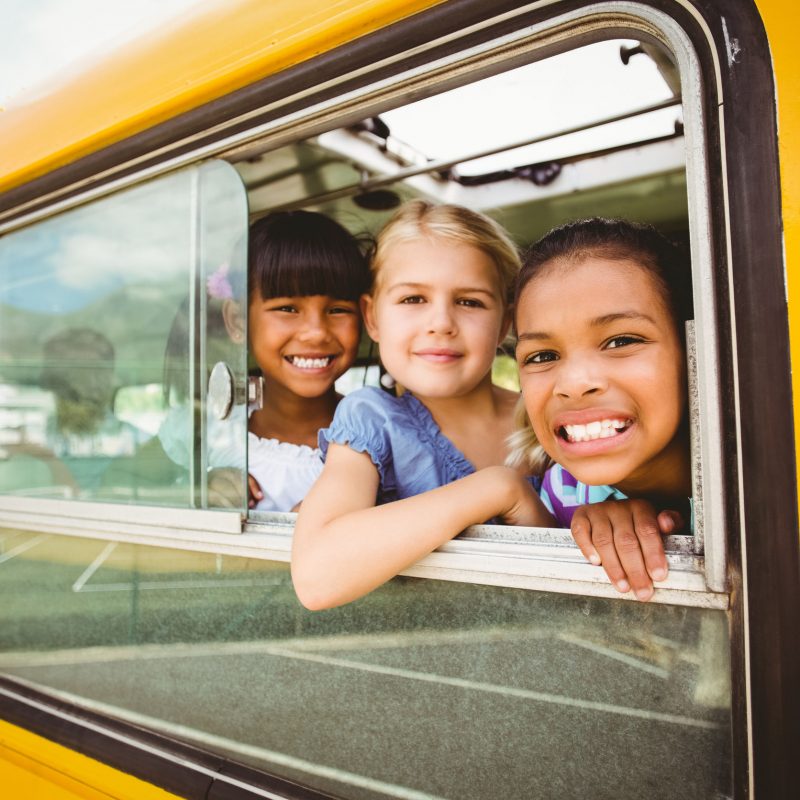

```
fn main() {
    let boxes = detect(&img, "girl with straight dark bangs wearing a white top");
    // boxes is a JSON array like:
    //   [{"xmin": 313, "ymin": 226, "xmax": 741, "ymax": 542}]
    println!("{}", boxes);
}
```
[{"xmin": 222, "ymin": 211, "xmax": 369, "ymax": 511}]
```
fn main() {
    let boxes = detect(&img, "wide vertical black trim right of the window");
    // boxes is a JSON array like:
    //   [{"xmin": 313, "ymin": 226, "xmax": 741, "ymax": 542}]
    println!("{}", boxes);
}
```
[{"xmin": 695, "ymin": 0, "xmax": 800, "ymax": 799}]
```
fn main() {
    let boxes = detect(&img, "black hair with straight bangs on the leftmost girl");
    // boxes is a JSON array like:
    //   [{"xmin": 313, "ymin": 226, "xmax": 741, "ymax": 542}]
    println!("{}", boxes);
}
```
[{"xmin": 247, "ymin": 211, "xmax": 370, "ymax": 300}]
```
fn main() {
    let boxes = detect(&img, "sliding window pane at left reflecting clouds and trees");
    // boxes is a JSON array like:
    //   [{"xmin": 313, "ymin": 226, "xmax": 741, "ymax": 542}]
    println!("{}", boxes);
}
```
[{"xmin": 0, "ymin": 162, "xmax": 247, "ymax": 506}]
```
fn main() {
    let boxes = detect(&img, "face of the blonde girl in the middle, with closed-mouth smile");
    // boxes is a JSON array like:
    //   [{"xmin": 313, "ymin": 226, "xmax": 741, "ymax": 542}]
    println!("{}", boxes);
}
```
[{"xmin": 362, "ymin": 238, "xmax": 509, "ymax": 399}]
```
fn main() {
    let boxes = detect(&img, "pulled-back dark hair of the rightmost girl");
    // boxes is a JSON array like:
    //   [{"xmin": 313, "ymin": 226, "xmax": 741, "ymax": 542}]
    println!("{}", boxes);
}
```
[{"xmin": 514, "ymin": 217, "xmax": 694, "ymax": 332}]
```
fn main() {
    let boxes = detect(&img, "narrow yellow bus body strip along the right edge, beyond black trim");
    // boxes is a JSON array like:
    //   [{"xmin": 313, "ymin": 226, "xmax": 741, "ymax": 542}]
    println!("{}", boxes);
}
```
[{"xmin": 757, "ymin": 0, "xmax": 800, "ymax": 500}]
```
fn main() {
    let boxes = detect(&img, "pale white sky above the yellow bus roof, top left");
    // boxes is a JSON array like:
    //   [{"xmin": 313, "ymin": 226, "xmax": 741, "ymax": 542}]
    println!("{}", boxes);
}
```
[{"xmin": 0, "ymin": 0, "xmax": 204, "ymax": 107}]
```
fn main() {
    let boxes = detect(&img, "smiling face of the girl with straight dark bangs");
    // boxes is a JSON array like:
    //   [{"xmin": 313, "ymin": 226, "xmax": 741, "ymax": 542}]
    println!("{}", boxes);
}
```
[{"xmin": 248, "ymin": 294, "xmax": 361, "ymax": 398}]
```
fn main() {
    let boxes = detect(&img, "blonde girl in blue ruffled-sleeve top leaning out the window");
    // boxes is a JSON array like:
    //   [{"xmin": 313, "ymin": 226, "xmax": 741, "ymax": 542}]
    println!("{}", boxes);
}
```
[{"xmin": 292, "ymin": 201, "xmax": 552, "ymax": 609}]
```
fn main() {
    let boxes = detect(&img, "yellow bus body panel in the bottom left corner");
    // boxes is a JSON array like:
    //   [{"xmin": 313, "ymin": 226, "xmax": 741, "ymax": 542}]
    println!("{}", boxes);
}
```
[{"xmin": 0, "ymin": 721, "xmax": 177, "ymax": 800}]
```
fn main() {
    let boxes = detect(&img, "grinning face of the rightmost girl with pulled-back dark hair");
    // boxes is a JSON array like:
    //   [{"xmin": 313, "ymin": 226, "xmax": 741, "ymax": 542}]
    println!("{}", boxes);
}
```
[{"xmin": 516, "ymin": 257, "xmax": 686, "ymax": 493}]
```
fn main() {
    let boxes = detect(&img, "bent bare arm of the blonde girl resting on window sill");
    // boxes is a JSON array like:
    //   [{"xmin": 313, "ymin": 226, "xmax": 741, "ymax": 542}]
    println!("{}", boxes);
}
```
[{"xmin": 292, "ymin": 444, "xmax": 553, "ymax": 609}]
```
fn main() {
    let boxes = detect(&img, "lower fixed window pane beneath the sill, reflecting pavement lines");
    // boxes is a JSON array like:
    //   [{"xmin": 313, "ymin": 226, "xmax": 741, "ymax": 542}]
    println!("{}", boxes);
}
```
[{"xmin": 0, "ymin": 530, "xmax": 730, "ymax": 800}]
